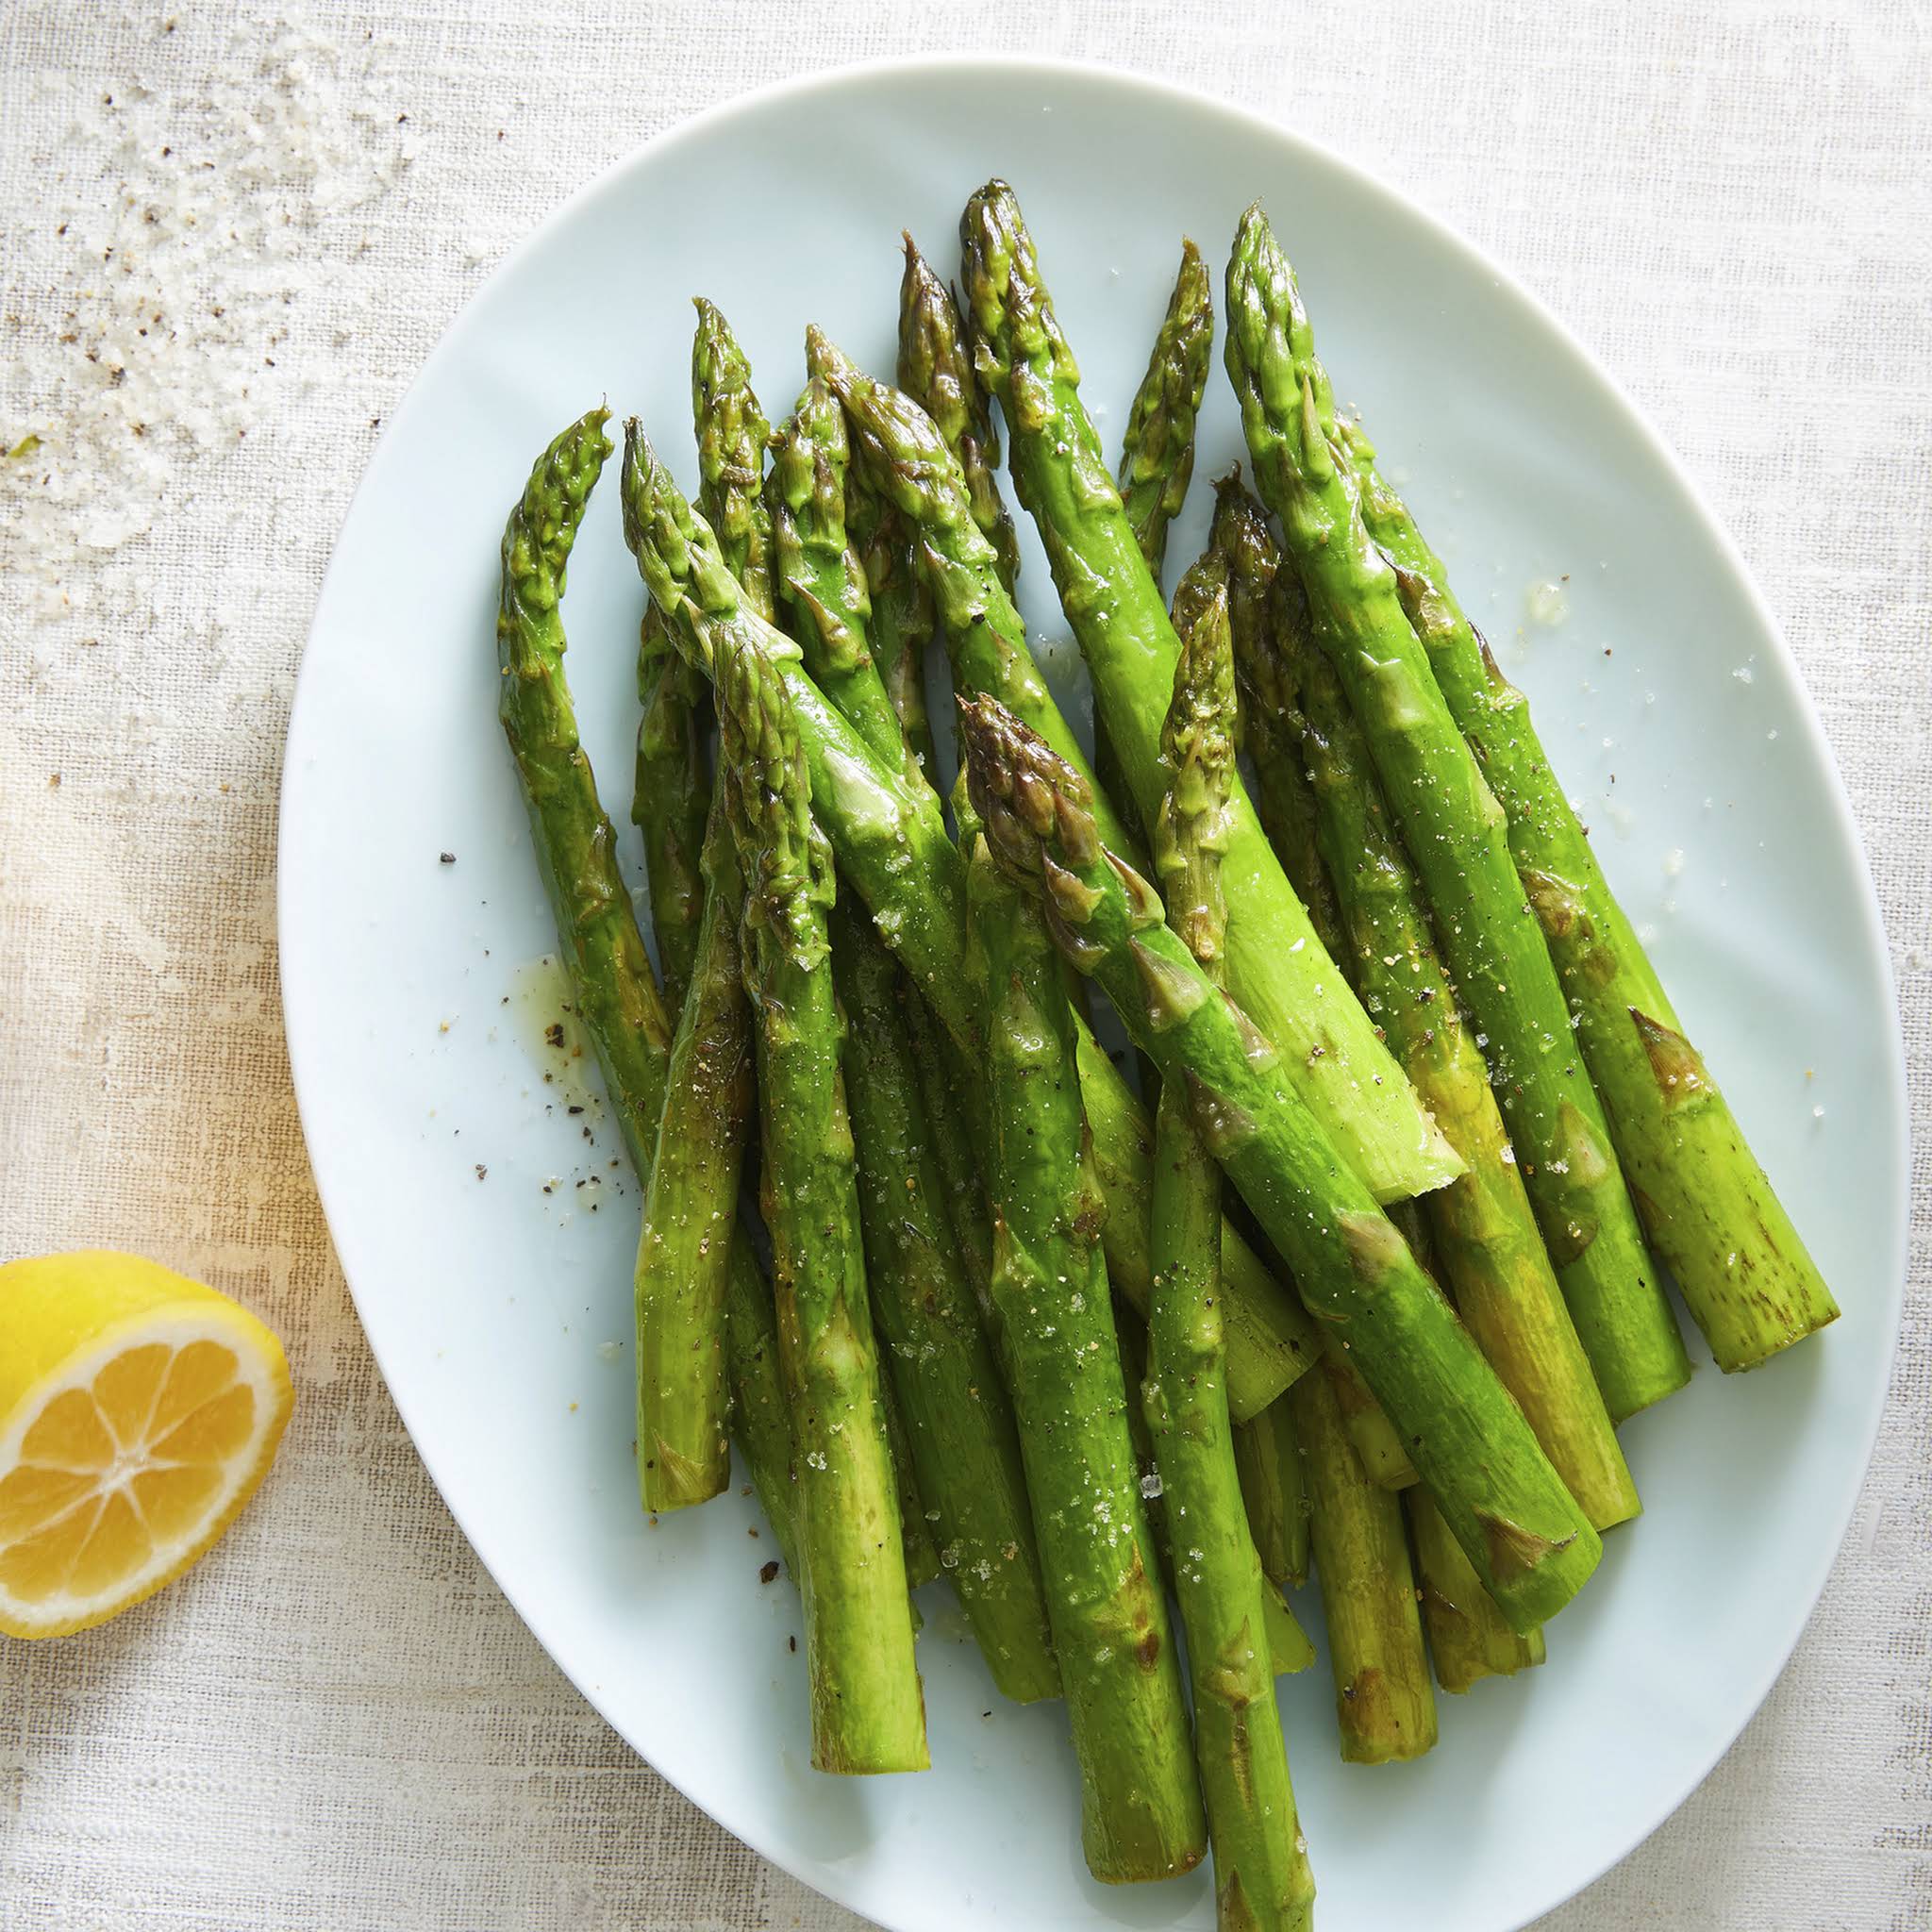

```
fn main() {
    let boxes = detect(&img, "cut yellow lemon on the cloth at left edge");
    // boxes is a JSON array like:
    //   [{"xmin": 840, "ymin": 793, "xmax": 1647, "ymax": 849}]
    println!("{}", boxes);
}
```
[{"xmin": 0, "ymin": 1250, "xmax": 293, "ymax": 1637}]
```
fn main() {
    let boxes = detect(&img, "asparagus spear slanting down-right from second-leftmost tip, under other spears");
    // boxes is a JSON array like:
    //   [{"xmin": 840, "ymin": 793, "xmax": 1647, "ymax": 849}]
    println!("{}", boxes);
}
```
[{"xmin": 622, "ymin": 424, "xmax": 1314, "ymax": 1420}]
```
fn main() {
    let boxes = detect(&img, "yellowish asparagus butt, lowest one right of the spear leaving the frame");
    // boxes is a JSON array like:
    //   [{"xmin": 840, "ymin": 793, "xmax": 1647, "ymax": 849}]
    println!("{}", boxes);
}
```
[{"xmin": 1289, "ymin": 1372, "xmax": 1436, "ymax": 1764}]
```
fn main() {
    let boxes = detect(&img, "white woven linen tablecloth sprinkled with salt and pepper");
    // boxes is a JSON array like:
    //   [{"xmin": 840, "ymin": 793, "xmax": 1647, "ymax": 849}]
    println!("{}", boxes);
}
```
[{"xmin": 0, "ymin": 0, "xmax": 1932, "ymax": 1932}]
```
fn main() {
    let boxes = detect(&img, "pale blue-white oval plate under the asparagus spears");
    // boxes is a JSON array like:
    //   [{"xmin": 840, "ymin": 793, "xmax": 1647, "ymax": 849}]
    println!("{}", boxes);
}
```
[{"xmin": 280, "ymin": 62, "xmax": 1905, "ymax": 1932}]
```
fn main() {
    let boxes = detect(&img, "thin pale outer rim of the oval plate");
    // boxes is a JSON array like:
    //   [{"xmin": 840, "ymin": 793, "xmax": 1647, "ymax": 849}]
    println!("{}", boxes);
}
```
[{"xmin": 275, "ymin": 50, "xmax": 1913, "ymax": 1932}]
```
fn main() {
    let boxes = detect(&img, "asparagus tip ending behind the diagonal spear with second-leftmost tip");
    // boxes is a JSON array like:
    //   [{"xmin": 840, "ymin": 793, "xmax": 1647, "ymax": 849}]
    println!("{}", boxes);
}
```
[{"xmin": 765, "ymin": 376, "xmax": 920, "ymax": 778}]
